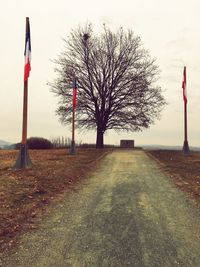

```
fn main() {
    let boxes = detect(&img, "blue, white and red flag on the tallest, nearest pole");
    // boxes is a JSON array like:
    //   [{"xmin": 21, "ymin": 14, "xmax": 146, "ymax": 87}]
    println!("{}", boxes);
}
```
[{"xmin": 24, "ymin": 18, "xmax": 31, "ymax": 81}]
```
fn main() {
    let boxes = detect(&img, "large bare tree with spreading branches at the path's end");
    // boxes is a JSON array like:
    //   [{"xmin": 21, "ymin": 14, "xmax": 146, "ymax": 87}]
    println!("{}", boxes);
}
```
[{"xmin": 50, "ymin": 25, "xmax": 165, "ymax": 148}]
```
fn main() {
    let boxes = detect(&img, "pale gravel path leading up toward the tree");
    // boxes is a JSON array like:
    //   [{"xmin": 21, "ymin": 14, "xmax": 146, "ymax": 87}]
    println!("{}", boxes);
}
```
[{"xmin": 0, "ymin": 151, "xmax": 200, "ymax": 267}]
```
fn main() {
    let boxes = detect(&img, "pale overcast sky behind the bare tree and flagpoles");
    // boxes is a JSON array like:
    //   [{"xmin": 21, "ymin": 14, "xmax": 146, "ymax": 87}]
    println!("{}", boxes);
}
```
[{"xmin": 0, "ymin": 0, "xmax": 200, "ymax": 146}]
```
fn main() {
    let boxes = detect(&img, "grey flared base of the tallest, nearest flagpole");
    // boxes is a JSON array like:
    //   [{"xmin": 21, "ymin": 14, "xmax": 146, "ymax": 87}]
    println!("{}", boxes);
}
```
[{"xmin": 13, "ymin": 144, "xmax": 32, "ymax": 169}]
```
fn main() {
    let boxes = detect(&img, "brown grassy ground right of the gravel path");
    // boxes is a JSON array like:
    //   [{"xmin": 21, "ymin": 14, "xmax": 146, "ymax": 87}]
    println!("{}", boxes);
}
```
[{"xmin": 146, "ymin": 150, "xmax": 200, "ymax": 207}]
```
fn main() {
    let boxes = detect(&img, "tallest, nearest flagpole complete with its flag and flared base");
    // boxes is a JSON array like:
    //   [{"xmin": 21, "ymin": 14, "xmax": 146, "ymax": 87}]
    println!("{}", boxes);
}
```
[{"xmin": 14, "ymin": 18, "xmax": 32, "ymax": 169}]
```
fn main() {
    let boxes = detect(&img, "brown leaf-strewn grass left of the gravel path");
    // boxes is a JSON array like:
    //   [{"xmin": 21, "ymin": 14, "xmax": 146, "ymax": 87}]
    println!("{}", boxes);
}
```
[{"xmin": 0, "ymin": 149, "xmax": 110, "ymax": 253}]
